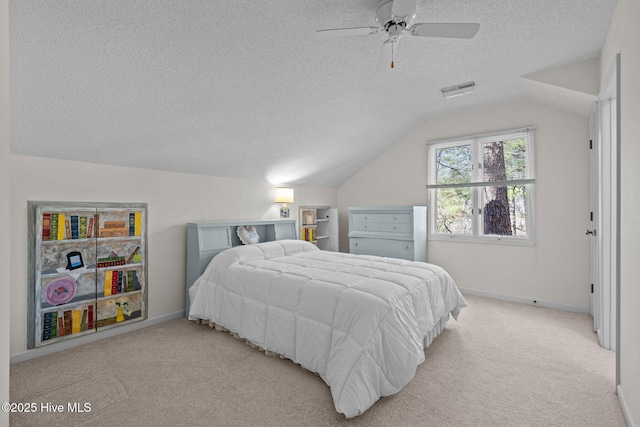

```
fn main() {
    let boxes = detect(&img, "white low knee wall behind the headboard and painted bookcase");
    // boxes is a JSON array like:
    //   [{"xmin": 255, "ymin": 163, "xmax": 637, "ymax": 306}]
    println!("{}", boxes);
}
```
[{"xmin": 10, "ymin": 155, "xmax": 337, "ymax": 358}]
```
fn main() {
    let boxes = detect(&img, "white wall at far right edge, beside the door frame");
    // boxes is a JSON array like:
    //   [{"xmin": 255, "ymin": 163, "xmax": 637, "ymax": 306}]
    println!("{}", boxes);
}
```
[{"xmin": 600, "ymin": 0, "xmax": 640, "ymax": 426}]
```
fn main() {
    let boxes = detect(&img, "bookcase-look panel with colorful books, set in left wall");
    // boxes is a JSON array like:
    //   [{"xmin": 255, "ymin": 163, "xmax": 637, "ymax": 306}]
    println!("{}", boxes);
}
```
[{"xmin": 27, "ymin": 201, "xmax": 147, "ymax": 348}]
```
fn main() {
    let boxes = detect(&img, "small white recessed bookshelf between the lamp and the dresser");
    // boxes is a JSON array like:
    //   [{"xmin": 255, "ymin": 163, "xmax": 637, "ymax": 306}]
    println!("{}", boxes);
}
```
[{"xmin": 298, "ymin": 206, "xmax": 338, "ymax": 252}]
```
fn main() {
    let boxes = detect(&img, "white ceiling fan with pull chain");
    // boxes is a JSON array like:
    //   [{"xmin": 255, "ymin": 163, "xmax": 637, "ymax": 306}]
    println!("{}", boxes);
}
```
[{"xmin": 316, "ymin": 0, "xmax": 480, "ymax": 70}]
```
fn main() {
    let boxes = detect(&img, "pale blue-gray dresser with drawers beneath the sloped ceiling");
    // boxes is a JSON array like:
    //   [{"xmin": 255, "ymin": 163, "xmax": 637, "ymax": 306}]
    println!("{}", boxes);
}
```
[{"xmin": 349, "ymin": 206, "xmax": 427, "ymax": 262}]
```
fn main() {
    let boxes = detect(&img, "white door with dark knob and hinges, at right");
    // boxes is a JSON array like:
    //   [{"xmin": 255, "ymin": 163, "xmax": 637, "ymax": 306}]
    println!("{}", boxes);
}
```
[{"xmin": 586, "ymin": 56, "xmax": 618, "ymax": 351}]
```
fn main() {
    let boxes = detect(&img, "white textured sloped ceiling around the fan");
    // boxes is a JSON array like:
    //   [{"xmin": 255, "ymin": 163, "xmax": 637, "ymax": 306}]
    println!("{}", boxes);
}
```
[{"xmin": 10, "ymin": 0, "xmax": 616, "ymax": 186}]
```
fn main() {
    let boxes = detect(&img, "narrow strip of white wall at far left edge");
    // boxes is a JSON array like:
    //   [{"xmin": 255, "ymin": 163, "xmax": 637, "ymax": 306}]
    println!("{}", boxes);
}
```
[{"xmin": 0, "ymin": 0, "xmax": 11, "ymax": 426}]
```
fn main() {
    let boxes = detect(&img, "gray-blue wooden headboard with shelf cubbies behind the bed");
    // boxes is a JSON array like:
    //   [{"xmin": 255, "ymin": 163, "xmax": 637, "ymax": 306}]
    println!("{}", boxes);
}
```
[{"xmin": 185, "ymin": 219, "xmax": 297, "ymax": 316}]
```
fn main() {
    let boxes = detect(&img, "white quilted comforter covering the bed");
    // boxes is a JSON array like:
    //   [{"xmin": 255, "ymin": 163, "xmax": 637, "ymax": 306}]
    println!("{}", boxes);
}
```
[{"xmin": 189, "ymin": 240, "xmax": 466, "ymax": 418}]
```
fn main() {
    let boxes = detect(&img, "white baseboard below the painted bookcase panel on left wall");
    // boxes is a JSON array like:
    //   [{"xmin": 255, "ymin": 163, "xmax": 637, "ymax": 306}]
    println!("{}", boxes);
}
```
[{"xmin": 9, "ymin": 310, "xmax": 184, "ymax": 365}]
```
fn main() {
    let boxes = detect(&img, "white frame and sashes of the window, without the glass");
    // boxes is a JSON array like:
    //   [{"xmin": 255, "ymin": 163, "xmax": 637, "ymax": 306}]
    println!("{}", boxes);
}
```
[{"xmin": 427, "ymin": 126, "xmax": 535, "ymax": 246}]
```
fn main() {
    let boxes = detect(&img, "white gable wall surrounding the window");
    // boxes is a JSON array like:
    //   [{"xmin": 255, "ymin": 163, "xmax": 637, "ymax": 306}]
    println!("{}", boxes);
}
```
[{"xmin": 338, "ymin": 99, "xmax": 590, "ymax": 312}]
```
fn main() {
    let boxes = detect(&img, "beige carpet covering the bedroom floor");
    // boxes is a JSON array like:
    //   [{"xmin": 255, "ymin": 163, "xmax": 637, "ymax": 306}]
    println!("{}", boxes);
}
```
[{"xmin": 10, "ymin": 296, "xmax": 626, "ymax": 427}]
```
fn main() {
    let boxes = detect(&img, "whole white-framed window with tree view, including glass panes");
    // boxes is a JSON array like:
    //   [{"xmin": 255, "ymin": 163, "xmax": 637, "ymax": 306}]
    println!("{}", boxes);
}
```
[{"xmin": 427, "ymin": 127, "xmax": 535, "ymax": 244}]
